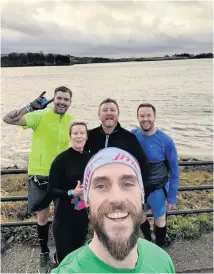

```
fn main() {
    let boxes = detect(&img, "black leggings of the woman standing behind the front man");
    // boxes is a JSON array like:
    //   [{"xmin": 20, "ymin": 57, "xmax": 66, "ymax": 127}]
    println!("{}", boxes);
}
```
[{"xmin": 53, "ymin": 209, "xmax": 88, "ymax": 263}]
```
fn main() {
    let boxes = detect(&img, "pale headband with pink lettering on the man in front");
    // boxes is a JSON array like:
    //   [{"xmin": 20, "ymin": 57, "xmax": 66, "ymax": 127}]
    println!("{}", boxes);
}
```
[{"xmin": 83, "ymin": 147, "xmax": 144, "ymax": 203}]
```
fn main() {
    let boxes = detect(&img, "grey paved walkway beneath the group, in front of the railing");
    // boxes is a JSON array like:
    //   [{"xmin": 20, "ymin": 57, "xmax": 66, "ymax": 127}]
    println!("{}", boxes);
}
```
[{"xmin": 1, "ymin": 233, "xmax": 213, "ymax": 273}]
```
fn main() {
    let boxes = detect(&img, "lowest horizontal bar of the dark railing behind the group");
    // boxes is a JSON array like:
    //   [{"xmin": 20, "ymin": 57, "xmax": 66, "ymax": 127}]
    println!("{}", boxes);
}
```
[{"xmin": 1, "ymin": 208, "xmax": 213, "ymax": 227}]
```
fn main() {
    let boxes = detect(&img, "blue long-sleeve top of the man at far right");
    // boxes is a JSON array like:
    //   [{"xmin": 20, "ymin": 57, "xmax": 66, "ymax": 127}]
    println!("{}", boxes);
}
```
[{"xmin": 131, "ymin": 128, "xmax": 179, "ymax": 204}]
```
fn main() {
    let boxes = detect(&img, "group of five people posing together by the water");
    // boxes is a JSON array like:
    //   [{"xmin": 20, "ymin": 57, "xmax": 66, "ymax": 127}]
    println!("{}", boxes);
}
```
[{"xmin": 3, "ymin": 86, "xmax": 179, "ymax": 273}]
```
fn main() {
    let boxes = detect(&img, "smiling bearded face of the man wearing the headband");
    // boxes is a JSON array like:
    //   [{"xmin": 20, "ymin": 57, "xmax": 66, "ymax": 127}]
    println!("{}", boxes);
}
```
[{"xmin": 89, "ymin": 164, "xmax": 142, "ymax": 260}]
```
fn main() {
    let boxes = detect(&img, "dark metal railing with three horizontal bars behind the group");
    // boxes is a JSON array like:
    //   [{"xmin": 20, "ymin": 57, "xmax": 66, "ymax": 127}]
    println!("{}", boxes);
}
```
[{"xmin": 1, "ymin": 161, "xmax": 213, "ymax": 227}]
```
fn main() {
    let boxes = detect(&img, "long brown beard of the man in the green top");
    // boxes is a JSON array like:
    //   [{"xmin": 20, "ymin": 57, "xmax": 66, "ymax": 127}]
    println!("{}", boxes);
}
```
[{"xmin": 90, "ymin": 202, "xmax": 142, "ymax": 261}]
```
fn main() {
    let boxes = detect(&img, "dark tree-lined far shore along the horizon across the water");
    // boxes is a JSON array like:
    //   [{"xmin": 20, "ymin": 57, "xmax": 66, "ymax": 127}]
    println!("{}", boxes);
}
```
[{"xmin": 1, "ymin": 51, "xmax": 213, "ymax": 67}]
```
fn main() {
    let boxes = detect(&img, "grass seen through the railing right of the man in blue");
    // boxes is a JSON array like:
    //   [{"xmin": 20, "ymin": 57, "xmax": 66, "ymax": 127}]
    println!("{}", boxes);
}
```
[{"xmin": 168, "ymin": 171, "xmax": 213, "ymax": 239}]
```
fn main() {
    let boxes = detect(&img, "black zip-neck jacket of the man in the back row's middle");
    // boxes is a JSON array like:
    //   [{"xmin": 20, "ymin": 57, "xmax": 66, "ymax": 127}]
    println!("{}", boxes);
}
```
[{"xmin": 85, "ymin": 123, "xmax": 149, "ymax": 186}]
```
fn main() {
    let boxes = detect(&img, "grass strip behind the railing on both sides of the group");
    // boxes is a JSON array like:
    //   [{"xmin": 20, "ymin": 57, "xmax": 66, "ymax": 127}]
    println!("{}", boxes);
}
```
[{"xmin": 1, "ymin": 171, "xmax": 213, "ymax": 239}]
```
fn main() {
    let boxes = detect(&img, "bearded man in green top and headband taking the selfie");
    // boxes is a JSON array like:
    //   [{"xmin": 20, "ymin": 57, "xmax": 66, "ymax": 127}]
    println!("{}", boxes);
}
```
[{"xmin": 52, "ymin": 147, "xmax": 175, "ymax": 273}]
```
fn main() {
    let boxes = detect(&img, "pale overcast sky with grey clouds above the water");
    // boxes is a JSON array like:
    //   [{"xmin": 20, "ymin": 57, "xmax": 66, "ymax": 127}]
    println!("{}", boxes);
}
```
[{"xmin": 1, "ymin": 0, "xmax": 213, "ymax": 57}]
